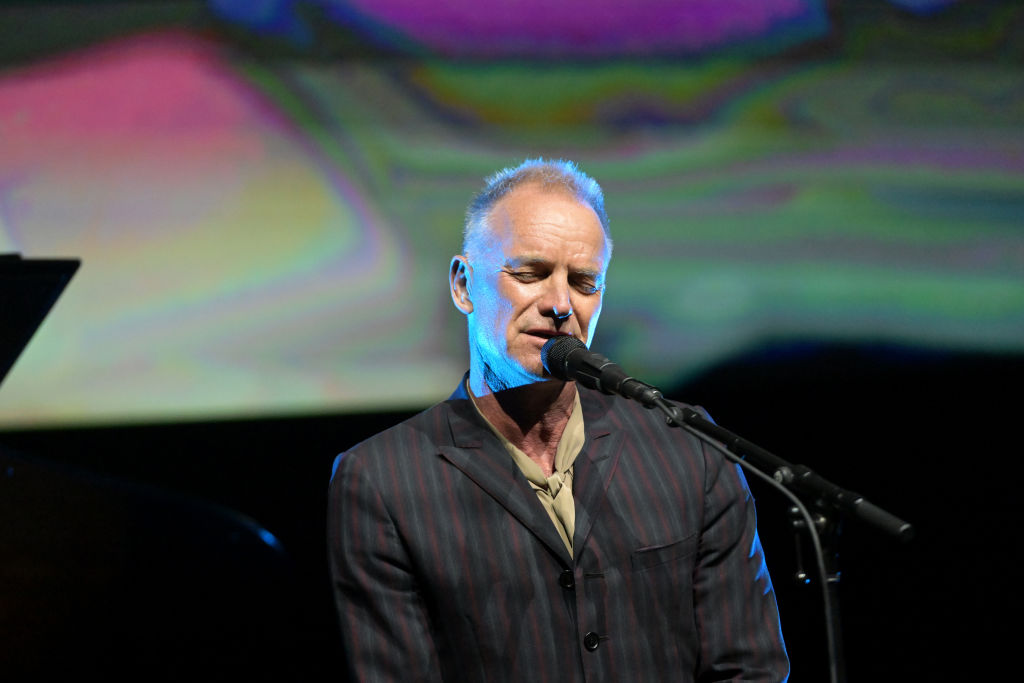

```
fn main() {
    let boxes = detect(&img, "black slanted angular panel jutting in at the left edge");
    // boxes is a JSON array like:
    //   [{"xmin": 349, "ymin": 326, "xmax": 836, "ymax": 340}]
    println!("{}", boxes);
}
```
[{"xmin": 0, "ymin": 254, "xmax": 81, "ymax": 383}]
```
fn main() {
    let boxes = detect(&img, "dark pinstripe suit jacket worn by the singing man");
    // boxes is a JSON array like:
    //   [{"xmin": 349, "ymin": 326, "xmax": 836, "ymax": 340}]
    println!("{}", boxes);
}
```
[{"xmin": 329, "ymin": 385, "xmax": 788, "ymax": 683}]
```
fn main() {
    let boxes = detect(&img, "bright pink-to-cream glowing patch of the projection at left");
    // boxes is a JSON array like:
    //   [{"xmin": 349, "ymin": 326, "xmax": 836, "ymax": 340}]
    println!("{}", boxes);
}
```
[{"xmin": 0, "ymin": 35, "xmax": 462, "ymax": 424}]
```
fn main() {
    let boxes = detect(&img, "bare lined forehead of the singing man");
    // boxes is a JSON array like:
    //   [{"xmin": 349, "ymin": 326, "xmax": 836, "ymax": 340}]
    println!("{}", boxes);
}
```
[{"xmin": 486, "ymin": 184, "xmax": 607, "ymax": 269}]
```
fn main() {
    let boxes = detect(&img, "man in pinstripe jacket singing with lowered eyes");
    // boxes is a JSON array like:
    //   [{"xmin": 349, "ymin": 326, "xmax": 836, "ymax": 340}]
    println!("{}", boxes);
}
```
[{"xmin": 329, "ymin": 160, "xmax": 788, "ymax": 682}]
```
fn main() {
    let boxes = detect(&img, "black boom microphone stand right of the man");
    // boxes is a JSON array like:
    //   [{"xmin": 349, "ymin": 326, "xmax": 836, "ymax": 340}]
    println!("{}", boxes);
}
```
[{"xmin": 643, "ymin": 397, "xmax": 913, "ymax": 683}]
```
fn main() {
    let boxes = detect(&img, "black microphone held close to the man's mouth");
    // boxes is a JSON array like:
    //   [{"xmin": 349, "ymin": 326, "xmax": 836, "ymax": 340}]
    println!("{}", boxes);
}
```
[{"xmin": 541, "ymin": 335, "xmax": 664, "ymax": 408}]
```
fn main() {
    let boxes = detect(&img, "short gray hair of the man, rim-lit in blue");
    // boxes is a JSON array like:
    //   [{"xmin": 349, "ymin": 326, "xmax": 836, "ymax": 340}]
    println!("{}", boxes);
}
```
[{"xmin": 462, "ymin": 158, "xmax": 611, "ymax": 255}]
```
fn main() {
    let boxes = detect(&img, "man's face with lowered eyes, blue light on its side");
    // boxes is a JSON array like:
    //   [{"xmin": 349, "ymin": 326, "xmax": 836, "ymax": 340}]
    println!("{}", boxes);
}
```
[{"xmin": 457, "ymin": 184, "xmax": 608, "ymax": 391}]
